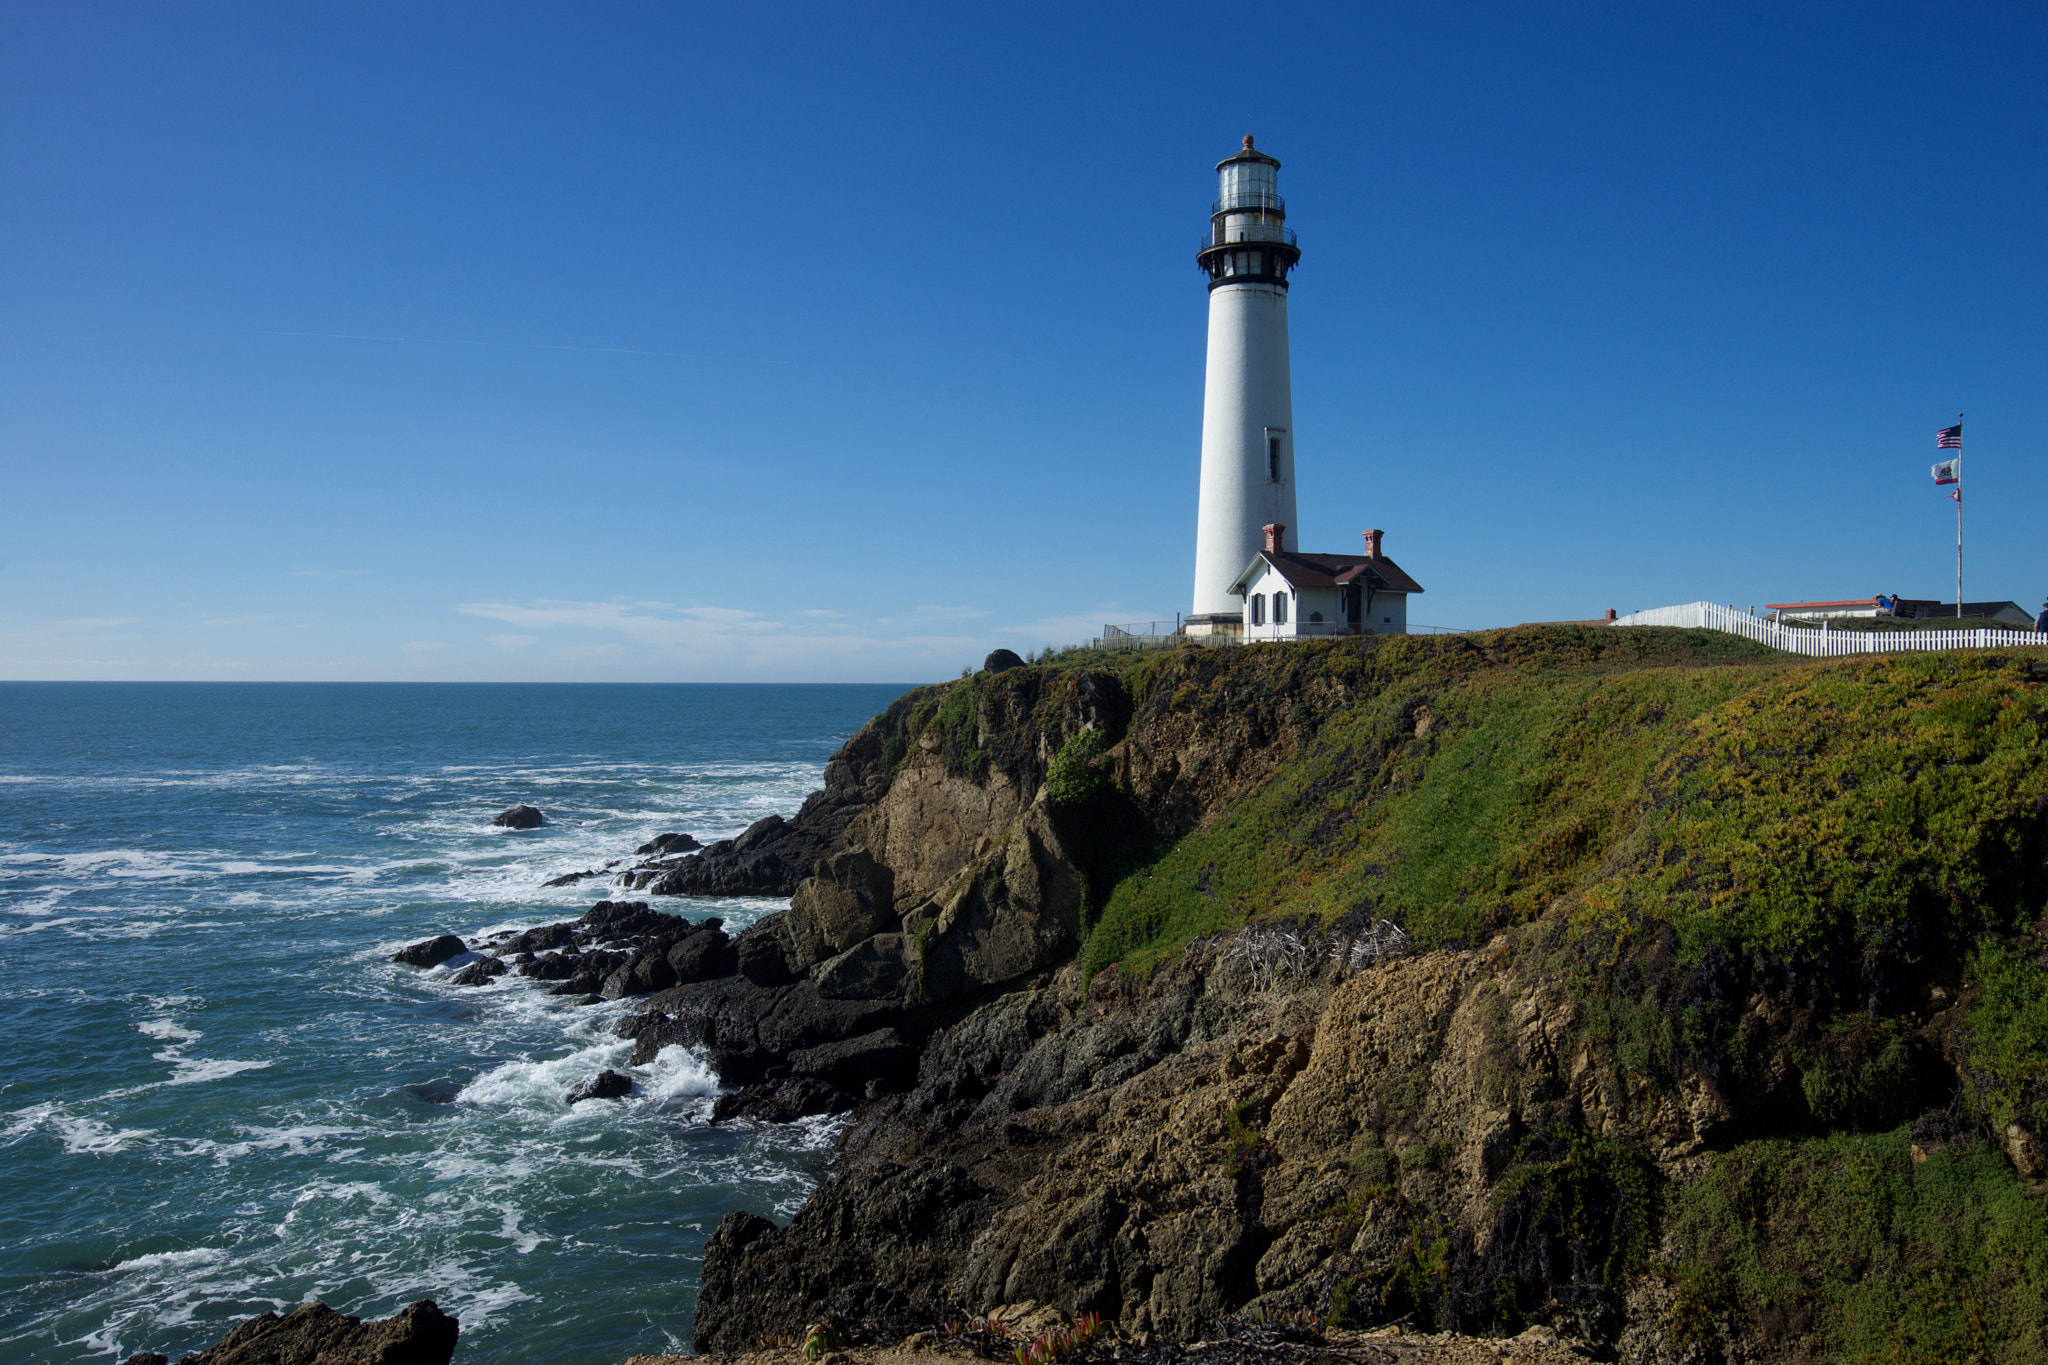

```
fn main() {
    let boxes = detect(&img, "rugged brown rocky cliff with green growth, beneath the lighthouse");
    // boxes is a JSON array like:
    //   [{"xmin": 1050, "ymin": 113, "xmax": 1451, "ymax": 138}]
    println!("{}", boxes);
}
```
[{"xmin": 663, "ymin": 628, "xmax": 2048, "ymax": 1361}]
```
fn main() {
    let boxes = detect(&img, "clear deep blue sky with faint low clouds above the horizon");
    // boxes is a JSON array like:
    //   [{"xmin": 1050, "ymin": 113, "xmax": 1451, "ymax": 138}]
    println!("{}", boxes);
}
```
[{"xmin": 0, "ymin": 2, "xmax": 2048, "ymax": 681}]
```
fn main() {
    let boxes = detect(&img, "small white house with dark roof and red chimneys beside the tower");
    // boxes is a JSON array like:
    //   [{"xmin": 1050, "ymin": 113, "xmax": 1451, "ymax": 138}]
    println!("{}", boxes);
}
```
[{"xmin": 1231, "ymin": 524, "xmax": 1421, "ymax": 641}]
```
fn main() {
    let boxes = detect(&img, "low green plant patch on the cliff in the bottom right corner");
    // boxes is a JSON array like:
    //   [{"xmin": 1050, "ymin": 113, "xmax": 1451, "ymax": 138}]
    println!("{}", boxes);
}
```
[{"xmin": 1667, "ymin": 1128, "xmax": 2048, "ymax": 1365}]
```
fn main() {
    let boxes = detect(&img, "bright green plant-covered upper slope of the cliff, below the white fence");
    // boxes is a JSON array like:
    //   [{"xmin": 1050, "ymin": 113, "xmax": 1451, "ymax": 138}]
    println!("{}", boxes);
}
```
[{"xmin": 1085, "ymin": 632, "xmax": 2048, "ymax": 970}]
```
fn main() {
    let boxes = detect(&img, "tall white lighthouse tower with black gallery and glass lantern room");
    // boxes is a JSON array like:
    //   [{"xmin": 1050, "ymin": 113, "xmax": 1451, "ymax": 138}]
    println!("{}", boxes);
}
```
[{"xmin": 1188, "ymin": 133, "xmax": 1300, "ymax": 634}]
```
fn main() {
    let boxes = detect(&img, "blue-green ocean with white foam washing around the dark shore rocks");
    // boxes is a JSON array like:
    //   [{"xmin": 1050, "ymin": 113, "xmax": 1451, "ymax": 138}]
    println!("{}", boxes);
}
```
[{"xmin": 0, "ymin": 684, "xmax": 903, "ymax": 1365}]
